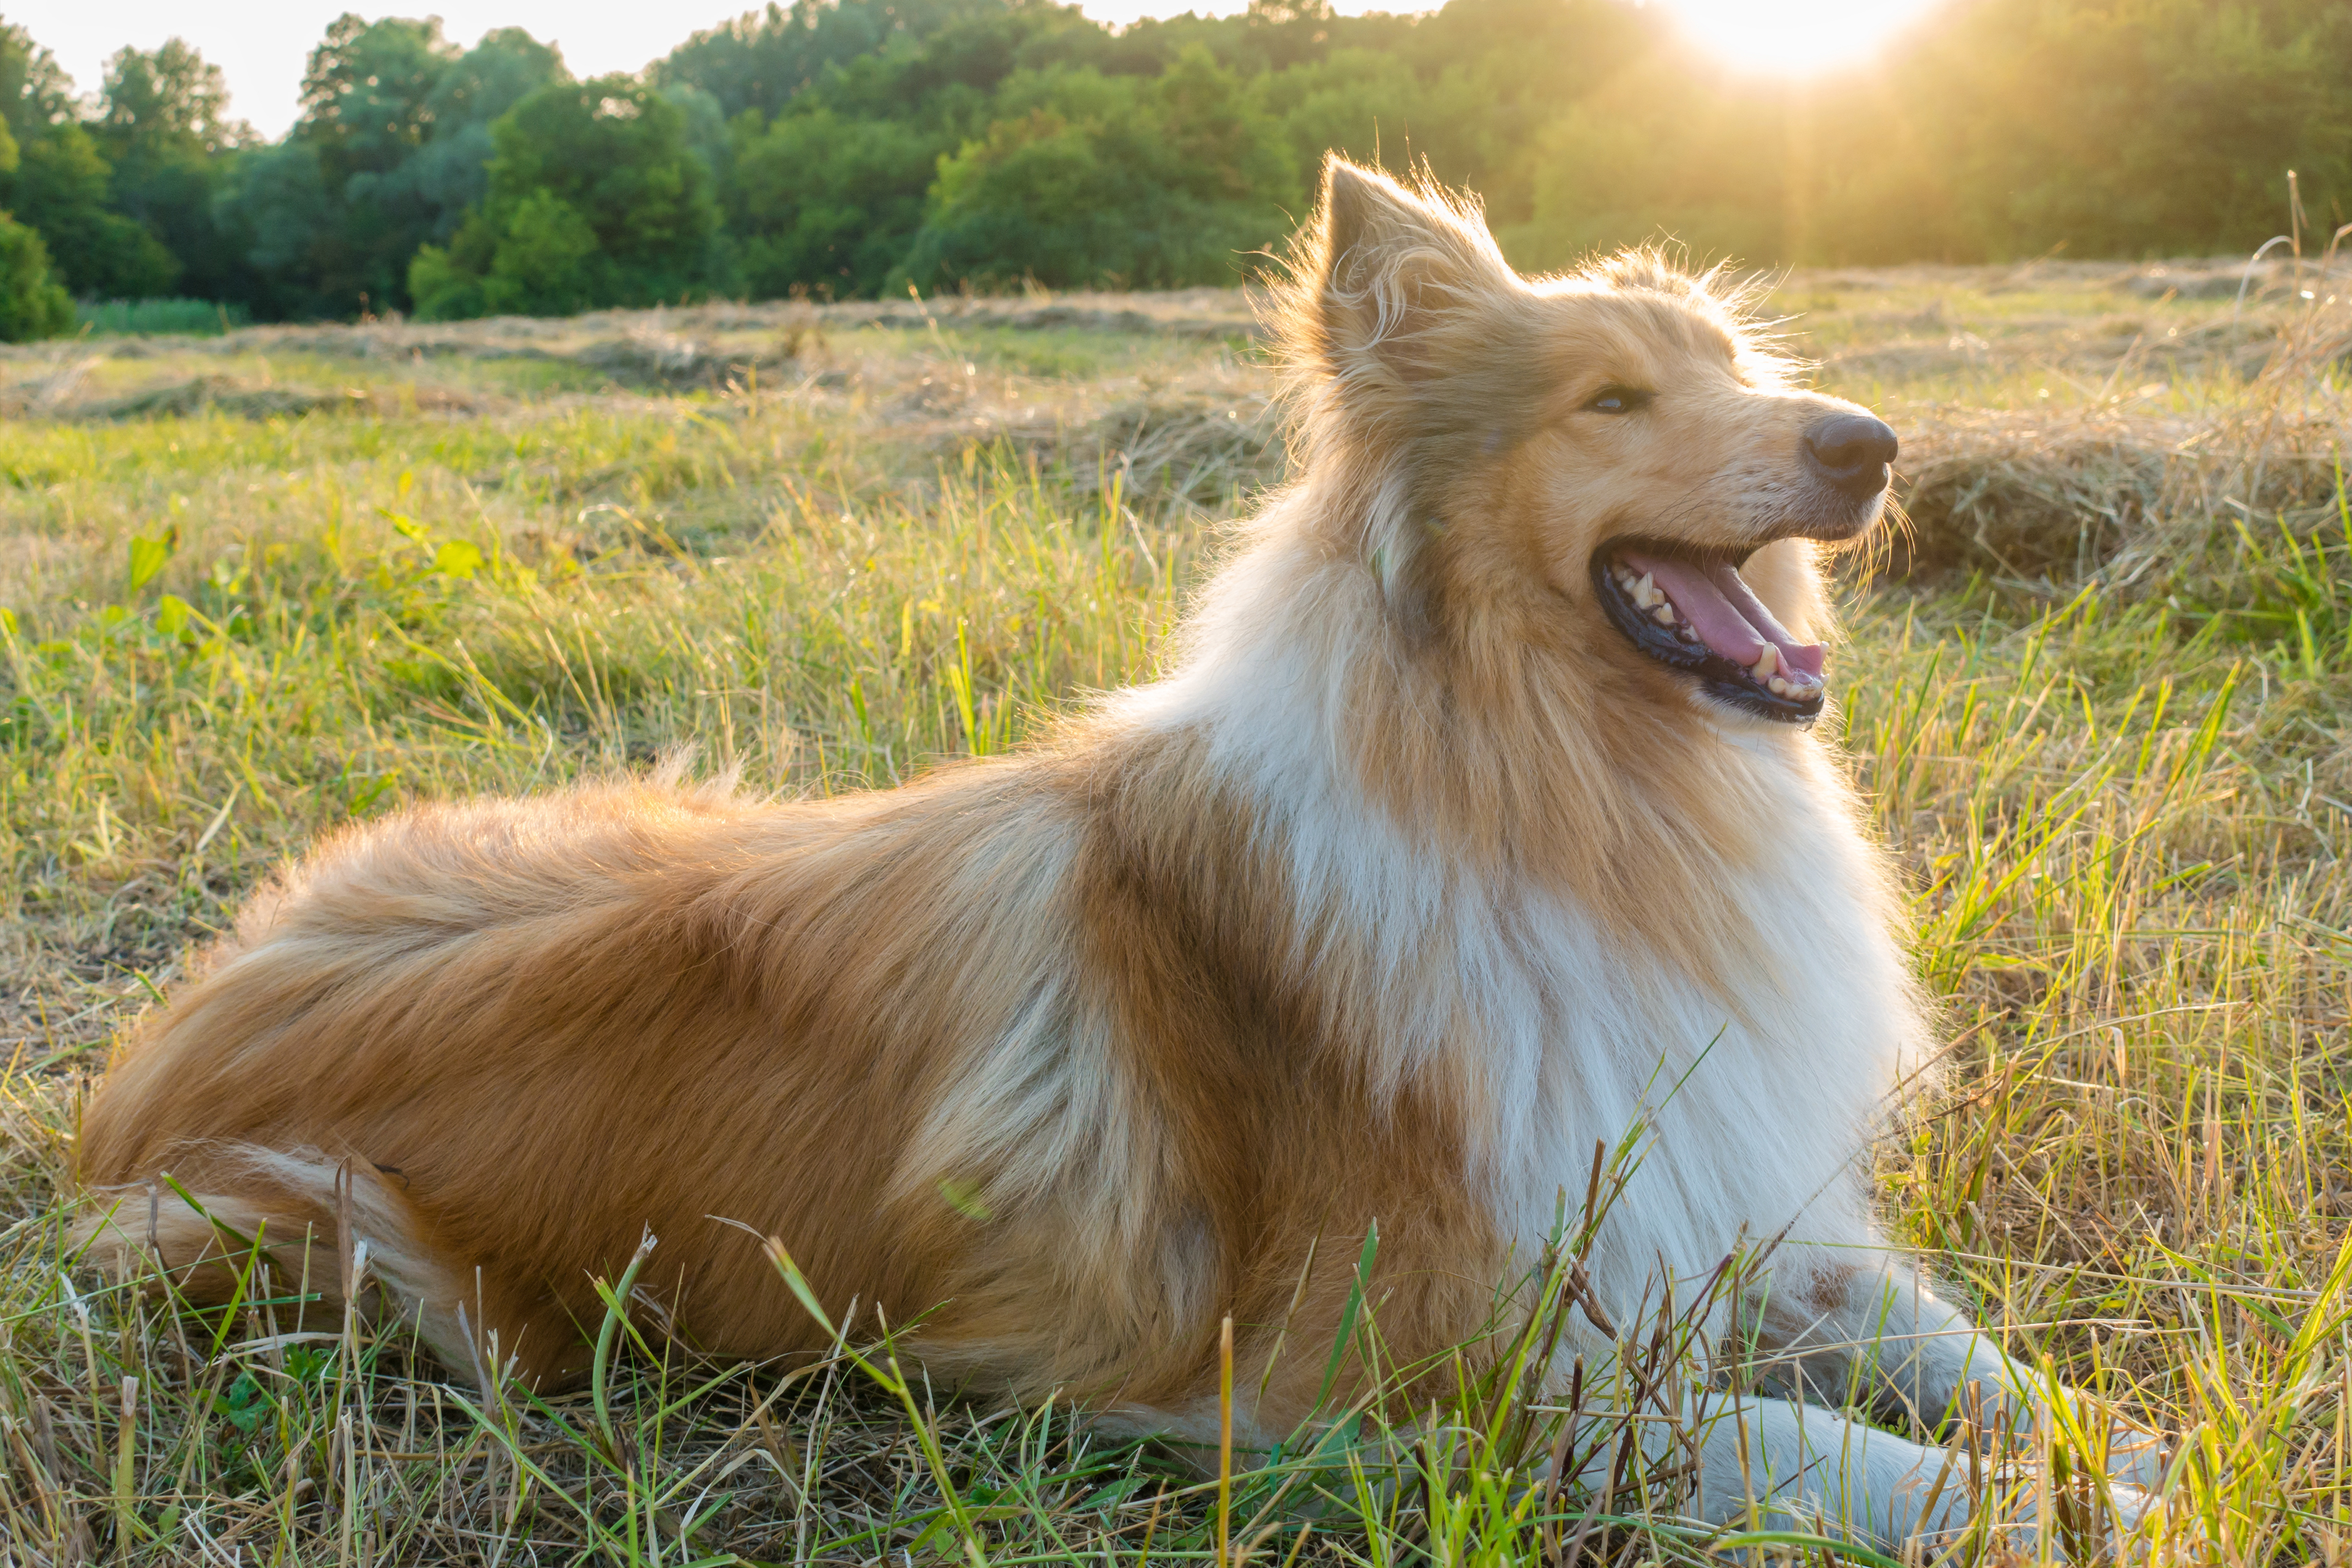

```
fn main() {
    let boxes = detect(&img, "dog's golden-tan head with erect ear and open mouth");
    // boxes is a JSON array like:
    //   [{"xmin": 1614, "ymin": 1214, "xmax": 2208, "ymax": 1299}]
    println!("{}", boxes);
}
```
[{"xmin": 1284, "ymin": 157, "xmax": 1896, "ymax": 722}]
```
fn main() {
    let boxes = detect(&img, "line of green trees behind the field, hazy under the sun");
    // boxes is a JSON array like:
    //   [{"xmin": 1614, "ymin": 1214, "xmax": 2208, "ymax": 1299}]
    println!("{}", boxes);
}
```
[{"xmin": 0, "ymin": 0, "xmax": 2352, "ymax": 341}]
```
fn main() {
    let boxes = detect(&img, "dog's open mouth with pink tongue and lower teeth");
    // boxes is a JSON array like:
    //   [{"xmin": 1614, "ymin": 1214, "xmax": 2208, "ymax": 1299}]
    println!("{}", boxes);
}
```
[{"xmin": 1592, "ymin": 538, "xmax": 1827, "ymax": 724}]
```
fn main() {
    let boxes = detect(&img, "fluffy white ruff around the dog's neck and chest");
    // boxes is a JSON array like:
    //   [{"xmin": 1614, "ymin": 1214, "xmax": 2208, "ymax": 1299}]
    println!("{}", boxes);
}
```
[{"xmin": 1117, "ymin": 524, "xmax": 1924, "ymax": 1321}]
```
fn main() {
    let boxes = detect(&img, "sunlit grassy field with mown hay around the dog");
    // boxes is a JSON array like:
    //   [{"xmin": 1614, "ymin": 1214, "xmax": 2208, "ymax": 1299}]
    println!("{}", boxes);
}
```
[{"xmin": 0, "ymin": 251, "xmax": 2352, "ymax": 1568}]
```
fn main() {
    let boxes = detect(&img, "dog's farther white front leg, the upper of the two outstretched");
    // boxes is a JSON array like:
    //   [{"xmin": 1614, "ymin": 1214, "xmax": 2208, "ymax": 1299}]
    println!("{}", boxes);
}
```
[{"xmin": 1759, "ymin": 1257, "xmax": 2166, "ymax": 1490}]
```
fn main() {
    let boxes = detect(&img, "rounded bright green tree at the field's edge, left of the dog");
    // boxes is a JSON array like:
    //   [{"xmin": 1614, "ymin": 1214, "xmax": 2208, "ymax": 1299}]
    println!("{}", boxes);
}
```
[{"xmin": 409, "ymin": 75, "xmax": 720, "ymax": 317}]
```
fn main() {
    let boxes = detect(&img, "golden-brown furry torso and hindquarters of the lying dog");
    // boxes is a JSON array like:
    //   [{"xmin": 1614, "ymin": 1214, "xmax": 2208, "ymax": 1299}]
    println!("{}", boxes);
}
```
[{"xmin": 80, "ymin": 738, "xmax": 1487, "ymax": 1413}]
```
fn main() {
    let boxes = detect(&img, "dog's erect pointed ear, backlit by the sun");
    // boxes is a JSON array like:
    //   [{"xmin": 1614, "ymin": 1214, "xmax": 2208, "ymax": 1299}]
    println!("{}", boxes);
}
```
[{"xmin": 1310, "ymin": 153, "xmax": 1517, "ymax": 381}]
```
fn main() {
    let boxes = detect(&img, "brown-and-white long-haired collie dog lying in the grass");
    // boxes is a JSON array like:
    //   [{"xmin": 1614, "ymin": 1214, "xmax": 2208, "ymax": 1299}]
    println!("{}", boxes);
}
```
[{"xmin": 80, "ymin": 160, "xmax": 2133, "ymax": 1542}]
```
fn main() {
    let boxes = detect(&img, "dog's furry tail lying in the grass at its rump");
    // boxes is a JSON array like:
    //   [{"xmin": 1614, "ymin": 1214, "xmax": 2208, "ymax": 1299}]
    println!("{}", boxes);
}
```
[{"xmin": 70, "ymin": 1142, "xmax": 484, "ymax": 1378}]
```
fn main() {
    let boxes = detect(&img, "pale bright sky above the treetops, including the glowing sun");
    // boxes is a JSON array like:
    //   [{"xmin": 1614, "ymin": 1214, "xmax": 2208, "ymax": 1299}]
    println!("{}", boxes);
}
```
[{"xmin": 7, "ymin": 0, "xmax": 1936, "ymax": 137}]
